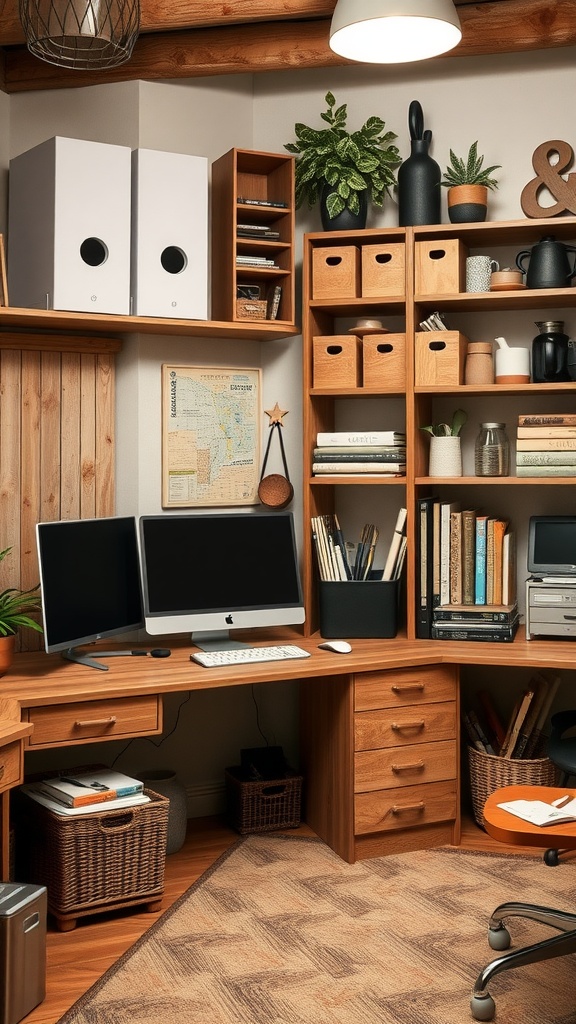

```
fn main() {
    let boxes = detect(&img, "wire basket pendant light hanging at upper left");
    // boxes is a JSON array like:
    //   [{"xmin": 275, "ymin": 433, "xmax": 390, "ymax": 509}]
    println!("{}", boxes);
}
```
[{"xmin": 19, "ymin": 0, "xmax": 140, "ymax": 71}]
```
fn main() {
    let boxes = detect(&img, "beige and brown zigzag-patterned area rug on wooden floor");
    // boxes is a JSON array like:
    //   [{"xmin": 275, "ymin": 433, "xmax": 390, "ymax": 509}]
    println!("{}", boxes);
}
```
[{"xmin": 57, "ymin": 835, "xmax": 576, "ymax": 1024}]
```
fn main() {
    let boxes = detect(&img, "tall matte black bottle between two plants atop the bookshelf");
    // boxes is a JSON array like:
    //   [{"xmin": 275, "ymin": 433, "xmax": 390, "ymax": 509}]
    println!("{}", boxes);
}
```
[{"xmin": 398, "ymin": 99, "xmax": 441, "ymax": 227}]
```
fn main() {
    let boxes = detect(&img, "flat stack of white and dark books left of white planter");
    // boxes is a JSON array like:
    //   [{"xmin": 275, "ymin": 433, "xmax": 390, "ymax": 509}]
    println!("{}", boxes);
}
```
[{"xmin": 312, "ymin": 430, "xmax": 406, "ymax": 476}]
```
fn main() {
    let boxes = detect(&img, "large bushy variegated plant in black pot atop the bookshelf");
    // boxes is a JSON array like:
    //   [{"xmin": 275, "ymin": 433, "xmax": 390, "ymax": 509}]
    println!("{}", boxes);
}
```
[{"xmin": 284, "ymin": 92, "xmax": 402, "ymax": 230}]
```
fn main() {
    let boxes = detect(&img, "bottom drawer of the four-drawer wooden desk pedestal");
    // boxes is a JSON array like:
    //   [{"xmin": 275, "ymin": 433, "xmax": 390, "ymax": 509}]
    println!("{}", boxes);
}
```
[{"xmin": 354, "ymin": 780, "xmax": 457, "ymax": 836}]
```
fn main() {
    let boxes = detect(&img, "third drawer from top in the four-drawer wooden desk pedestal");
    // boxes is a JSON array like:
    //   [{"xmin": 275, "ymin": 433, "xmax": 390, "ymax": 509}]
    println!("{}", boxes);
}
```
[{"xmin": 354, "ymin": 739, "xmax": 457, "ymax": 793}]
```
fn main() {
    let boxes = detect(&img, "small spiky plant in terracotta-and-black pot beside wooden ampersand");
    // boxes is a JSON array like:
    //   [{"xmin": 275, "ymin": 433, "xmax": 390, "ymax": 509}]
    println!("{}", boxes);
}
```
[{"xmin": 440, "ymin": 140, "xmax": 501, "ymax": 224}]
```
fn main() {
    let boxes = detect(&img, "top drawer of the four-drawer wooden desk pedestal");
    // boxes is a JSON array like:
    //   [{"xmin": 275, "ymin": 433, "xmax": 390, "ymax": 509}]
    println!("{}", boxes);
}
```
[{"xmin": 354, "ymin": 665, "xmax": 457, "ymax": 711}]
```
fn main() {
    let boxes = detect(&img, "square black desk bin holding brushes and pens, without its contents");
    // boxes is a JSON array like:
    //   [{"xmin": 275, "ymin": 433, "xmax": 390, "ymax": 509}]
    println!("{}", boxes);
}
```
[{"xmin": 320, "ymin": 580, "xmax": 400, "ymax": 640}]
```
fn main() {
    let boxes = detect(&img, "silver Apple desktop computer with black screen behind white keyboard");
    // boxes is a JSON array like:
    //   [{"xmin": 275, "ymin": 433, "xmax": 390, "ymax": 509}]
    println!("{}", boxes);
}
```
[{"xmin": 139, "ymin": 512, "xmax": 304, "ymax": 650}]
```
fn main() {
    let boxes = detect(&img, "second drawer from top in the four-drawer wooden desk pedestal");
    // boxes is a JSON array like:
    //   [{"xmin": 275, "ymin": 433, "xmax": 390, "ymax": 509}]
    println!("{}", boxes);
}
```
[{"xmin": 354, "ymin": 700, "xmax": 456, "ymax": 751}]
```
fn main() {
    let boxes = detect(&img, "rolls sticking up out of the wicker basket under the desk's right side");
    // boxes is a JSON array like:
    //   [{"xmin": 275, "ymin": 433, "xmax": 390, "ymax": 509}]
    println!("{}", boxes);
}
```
[{"xmin": 462, "ymin": 670, "xmax": 561, "ymax": 759}]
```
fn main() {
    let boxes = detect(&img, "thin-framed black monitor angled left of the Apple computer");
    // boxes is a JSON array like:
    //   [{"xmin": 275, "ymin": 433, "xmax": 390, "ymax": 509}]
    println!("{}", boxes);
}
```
[{"xmin": 36, "ymin": 516, "xmax": 143, "ymax": 670}]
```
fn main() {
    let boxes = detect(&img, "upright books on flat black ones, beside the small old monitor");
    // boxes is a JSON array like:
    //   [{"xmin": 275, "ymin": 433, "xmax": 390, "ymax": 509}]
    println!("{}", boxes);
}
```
[{"xmin": 416, "ymin": 498, "xmax": 512, "ymax": 641}]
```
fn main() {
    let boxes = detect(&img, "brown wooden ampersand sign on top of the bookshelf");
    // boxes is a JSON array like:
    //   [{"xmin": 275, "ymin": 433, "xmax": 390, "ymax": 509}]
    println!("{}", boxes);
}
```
[{"xmin": 520, "ymin": 139, "xmax": 576, "ymax": 217}]
